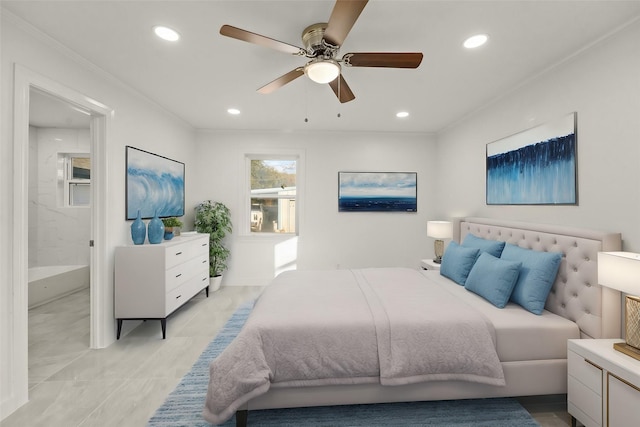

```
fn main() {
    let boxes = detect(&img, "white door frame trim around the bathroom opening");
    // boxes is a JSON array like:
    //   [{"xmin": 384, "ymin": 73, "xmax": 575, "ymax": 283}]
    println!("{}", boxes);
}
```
[{"xmin": 9, "ymin": 64, "xmax": 114, "ymax": 408}]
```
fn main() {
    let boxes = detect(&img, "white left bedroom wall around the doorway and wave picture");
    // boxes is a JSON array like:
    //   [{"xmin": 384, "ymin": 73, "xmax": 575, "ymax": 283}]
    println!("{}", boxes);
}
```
[{"xmin": 0, "ymin": 11, "xmax": 196, "ymax": 419}]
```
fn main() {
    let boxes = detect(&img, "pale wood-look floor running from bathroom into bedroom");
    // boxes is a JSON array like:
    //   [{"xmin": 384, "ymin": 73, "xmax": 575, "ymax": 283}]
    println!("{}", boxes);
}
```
[{"xmin": 0, "ymin": 287, "xmax": 569, "ymax": 427}]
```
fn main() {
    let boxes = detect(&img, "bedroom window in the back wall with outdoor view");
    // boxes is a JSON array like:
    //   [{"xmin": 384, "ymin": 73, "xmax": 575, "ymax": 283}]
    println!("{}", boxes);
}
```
[{"xmin": 247, "ymin": 156, "xmax": 298, "ymax": 234}]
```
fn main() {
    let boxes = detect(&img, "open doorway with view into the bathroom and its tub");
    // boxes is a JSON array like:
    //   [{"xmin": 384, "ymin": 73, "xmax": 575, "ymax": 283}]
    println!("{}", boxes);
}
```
[{"xmin": 27, "ymin": 87, "xmax": 92, "ymax": 388}]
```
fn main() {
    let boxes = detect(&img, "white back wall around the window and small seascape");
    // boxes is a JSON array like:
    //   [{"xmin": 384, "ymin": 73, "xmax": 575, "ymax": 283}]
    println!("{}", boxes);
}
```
[{"xmin": 190, "ymin": 131, "xmax": 436, "ymax": 285}]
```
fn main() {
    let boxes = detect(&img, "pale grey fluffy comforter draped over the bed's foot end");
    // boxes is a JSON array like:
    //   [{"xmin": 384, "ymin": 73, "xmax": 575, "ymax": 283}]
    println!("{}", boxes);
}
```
[{"xmin": 203, "ymin": 268, "xmax": 505, "ymax": 423}]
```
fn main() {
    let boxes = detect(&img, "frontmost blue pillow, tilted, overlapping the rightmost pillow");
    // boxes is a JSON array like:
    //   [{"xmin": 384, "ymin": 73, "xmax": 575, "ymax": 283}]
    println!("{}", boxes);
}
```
[{"xmin": 464, "ymin": 252, "xmax": 522, "ymax": 308}]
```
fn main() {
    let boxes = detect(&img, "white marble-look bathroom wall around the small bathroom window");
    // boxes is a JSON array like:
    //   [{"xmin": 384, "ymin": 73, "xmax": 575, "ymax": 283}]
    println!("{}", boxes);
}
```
[{"xmin": 29, "ymin": 126, "xmax": 91, "ymax": 267}]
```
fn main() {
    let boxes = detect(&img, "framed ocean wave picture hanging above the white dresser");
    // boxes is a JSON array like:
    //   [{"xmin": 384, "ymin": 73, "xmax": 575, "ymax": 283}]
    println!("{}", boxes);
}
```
[{"xmin": 126, "ymin": 146, "xmax": 184, "ymax": 220}]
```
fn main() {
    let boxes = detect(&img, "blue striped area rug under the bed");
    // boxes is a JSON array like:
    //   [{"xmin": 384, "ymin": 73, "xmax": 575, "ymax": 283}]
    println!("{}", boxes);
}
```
[{"xmin": 147, "ymin": 303, "xmax": 539, "ymax": 427}]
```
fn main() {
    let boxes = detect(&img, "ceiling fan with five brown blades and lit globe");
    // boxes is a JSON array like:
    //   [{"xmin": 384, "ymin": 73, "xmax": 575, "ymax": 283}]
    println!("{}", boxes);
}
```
[{"xmin": 220, "ymin": 0, "xmax": 422, "ymax": 103}]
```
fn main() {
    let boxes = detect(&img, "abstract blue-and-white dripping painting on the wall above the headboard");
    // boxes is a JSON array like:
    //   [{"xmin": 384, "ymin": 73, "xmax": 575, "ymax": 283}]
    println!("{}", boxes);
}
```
[{"xmin": 486, "ymin": 113, "xmax": 578, "ymax": 205}]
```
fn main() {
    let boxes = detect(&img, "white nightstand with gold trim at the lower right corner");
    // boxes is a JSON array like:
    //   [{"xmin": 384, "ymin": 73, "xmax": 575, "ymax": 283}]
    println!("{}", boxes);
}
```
[{"xmin": 567, "ymin": 339, "xmax": 640, "ymax": 427}]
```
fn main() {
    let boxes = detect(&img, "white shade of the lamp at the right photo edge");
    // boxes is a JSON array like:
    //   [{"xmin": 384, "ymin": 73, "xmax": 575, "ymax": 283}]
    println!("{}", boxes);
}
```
[{"xmin": 598, "ymin": 252, "xmax": 640, "ymax": 295}]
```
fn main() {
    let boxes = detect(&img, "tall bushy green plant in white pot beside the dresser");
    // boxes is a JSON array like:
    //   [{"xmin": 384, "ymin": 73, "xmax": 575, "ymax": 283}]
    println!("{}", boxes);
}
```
[{"xmin": 195, "ymin": 200, "xmax": 233, "ymax": 292}]
